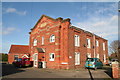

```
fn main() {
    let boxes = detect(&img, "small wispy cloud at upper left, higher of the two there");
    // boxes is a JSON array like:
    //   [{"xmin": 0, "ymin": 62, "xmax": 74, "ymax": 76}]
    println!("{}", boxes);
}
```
[{"xmin": 3, "ymin": 8, "xmax": 27, "ymax": 15}]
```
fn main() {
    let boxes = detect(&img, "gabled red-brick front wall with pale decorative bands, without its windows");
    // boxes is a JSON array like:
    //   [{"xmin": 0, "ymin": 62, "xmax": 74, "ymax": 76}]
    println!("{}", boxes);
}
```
[{"xmin": 30, "ymin": 17, "xmax": 60, "ymax": 68}]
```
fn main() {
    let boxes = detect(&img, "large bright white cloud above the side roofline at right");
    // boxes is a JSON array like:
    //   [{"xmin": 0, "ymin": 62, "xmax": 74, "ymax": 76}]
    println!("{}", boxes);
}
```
[{"xmin": 75, "ymin": 15, "xmax": 118, "ymax": 38}]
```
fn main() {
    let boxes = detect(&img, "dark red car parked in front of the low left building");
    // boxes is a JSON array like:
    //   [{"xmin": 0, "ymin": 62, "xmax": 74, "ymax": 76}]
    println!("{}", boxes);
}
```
[{"xmin": 12, "ymin": 58, "xmax": 33, "ymax": 67}]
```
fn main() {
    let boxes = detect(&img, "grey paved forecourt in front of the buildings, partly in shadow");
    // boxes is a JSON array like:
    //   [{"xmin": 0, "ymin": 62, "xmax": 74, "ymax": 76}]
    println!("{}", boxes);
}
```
[{"xmin": 2, "ymin": 64, "xmax": 112, "ymax": 80}]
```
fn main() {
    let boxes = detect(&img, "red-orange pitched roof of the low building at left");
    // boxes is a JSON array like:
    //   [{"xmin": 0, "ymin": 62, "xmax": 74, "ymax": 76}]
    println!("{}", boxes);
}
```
[{"xmin": 9, "ymin": 45, "xmax": 29, "ymax": 54}]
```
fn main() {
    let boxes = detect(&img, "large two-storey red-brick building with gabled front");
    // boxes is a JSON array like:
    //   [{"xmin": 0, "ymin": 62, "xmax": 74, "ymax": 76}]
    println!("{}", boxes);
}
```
[{"xmin": 29, "ymin": 15, "xmax": 108, "ymax": 69}]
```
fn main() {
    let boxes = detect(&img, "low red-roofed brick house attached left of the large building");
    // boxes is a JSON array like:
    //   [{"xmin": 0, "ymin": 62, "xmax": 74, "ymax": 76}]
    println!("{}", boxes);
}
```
[{"xmin": 8, "ymin": 45, "xmax": 30, "ymax": 64}]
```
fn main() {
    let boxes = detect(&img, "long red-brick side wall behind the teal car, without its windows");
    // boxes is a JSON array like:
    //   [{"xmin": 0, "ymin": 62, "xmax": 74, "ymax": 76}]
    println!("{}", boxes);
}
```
[{"xmin": 68, "ymin": 29, "xmax": 108, "ymax": 68}]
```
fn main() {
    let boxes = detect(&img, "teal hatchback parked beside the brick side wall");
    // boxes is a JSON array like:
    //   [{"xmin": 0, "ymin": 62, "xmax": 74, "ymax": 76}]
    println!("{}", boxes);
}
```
[{"xmin": 85, "ymin": 58, "xmax": 103, "ymax": 70}]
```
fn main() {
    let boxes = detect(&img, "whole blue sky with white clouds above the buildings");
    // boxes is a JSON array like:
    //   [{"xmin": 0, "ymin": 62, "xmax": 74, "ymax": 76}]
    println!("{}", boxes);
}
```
[{"xmin": 0, "ymin": 2, "xmax": 118, "ymax": 53}]
